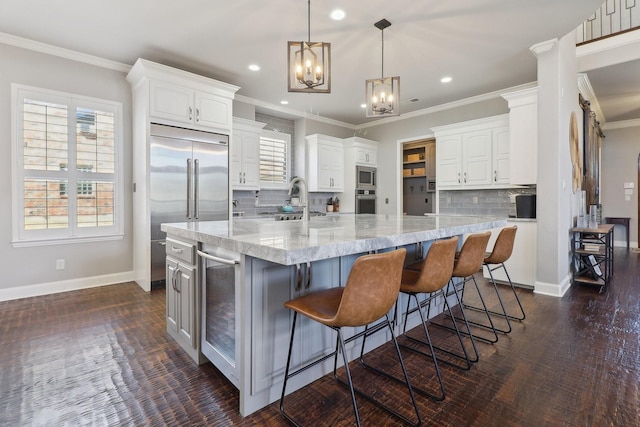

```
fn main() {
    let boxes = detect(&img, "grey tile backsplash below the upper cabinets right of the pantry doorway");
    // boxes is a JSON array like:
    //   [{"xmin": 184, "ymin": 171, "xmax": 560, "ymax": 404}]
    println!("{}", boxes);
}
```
[{"xmin": 439, "ymin": 187, "xmax": 536, "ymax": 217}]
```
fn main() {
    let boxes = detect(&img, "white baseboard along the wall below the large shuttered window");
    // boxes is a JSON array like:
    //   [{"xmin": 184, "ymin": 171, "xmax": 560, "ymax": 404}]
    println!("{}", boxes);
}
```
[{"xmin": 0, "ymin": 271, "xmax": 134, "ymax": 301}]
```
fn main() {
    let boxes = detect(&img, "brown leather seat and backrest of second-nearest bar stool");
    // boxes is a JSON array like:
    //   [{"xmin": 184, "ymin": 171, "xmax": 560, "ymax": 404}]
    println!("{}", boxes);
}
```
[{"xmin": 413, "ymin": 236, "xmax": 458, "ymax": 293}]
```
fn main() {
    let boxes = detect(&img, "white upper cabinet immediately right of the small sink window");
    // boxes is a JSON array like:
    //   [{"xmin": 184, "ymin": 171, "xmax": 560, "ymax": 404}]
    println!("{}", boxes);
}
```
[{"xmin": 306, "ymin": 134, "xmax": 344, "ymax": 193}]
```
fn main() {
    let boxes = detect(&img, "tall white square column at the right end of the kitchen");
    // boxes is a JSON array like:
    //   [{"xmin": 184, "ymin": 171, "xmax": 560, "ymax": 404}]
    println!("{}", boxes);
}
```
[{"xmin": 531, "ymin": 33, "xmax": 581, "ymax": 296}]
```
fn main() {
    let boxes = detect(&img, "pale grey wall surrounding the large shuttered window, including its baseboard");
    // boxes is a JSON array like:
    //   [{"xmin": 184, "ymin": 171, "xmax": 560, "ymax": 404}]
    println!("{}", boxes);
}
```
[{"xmin": 0, "ymin": 44, "xmax": 133, "ymax": 300}]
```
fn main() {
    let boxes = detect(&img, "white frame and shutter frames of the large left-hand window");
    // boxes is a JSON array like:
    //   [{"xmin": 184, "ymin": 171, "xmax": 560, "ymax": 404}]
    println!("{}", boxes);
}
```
[{"xmin": 11, "ymin": 83, "xmax": 124, "ymax": 247}]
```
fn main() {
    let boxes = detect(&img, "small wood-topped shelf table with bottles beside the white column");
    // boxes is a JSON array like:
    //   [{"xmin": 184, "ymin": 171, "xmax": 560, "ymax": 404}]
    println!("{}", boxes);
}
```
[{"xmin": 570, "ymin": 224, "xmax": 613, "ymax": 292}]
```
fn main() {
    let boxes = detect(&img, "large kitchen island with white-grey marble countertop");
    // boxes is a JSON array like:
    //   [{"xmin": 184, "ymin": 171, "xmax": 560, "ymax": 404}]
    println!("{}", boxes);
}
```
[{"xmin": 162, "ymin": 214, "xmax": 507, "ymax": 416}]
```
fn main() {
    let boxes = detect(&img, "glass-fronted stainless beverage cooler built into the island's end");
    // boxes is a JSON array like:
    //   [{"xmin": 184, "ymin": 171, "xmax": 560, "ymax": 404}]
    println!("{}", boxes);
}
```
[{"xmin": 198, "ymin": 245, "xmax": 241, "ymax": 387}]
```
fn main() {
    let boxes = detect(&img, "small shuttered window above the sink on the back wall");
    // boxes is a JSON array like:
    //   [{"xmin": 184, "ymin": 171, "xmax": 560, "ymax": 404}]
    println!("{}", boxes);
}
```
[{"xmin": 260, "ymin": 131, "xmax": 291, "ymax": 188}]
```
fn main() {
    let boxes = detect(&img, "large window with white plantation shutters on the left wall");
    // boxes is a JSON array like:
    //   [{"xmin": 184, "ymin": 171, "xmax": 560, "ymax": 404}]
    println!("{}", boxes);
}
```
[{"xmin": 13, "ymin": 85, "xmax": 122, "ymax": 244}]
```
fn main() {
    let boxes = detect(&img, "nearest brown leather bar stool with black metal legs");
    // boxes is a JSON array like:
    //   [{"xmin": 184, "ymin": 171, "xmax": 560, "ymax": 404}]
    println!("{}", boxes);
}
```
[{"xmin": 280, "ymin": 249, "xmax": 422, "ymax": 426}]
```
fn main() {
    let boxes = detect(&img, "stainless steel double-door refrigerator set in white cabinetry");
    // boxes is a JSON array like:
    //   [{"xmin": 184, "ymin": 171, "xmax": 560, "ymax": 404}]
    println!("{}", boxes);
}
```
[{"xmin": 149, "ymin": 123, "xmax": 229, "ymax": 285}]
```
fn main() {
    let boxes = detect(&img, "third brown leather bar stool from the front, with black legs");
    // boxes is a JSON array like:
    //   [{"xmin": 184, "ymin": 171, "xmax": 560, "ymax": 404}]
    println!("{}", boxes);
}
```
[{"xmin": 432, "ymin": 231, "xmax": 498, "ymax": 352}]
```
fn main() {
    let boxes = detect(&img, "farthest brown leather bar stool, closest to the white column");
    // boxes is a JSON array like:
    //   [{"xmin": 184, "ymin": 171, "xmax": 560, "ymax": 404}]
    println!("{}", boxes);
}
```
[{"xmin": 465, "ymin": 225, "xmax": 526, "ymax": 333}]
